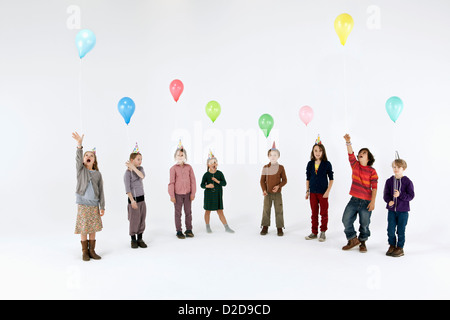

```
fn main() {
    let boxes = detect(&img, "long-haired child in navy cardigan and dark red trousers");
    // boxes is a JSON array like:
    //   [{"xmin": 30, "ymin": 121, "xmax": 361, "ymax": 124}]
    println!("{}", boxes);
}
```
[{"xmin": 305, "ymin": 137, "xmax": 333, "ymax": 242}]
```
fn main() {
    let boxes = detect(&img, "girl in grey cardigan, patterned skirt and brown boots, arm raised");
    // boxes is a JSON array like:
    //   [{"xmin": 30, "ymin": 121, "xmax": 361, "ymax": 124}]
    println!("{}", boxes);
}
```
[{"xmin": 72, "ymin": 132, "xmax": 105, "ymax": 261}]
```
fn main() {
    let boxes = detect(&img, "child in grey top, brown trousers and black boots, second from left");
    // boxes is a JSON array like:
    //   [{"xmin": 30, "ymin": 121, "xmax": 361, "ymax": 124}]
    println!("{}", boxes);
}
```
[{"xmin": 123, "ymin": 143, "xmax": 147, "ymax": 249}]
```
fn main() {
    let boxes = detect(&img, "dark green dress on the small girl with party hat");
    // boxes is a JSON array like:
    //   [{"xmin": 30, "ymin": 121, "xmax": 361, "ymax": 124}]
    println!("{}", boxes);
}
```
[{"xmin": 200, "ymin": 170, "xmax": 227, "ymax": 211}]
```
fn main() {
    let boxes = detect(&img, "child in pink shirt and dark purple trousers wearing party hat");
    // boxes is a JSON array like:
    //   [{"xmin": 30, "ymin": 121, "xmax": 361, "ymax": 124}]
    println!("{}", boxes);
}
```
[{"xmin": 169, "ymin": 141, "xmax": 197, "ymax": 239}]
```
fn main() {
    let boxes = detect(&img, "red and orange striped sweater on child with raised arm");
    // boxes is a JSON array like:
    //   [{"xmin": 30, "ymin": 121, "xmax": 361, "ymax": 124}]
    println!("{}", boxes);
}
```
[{"xmin": 348, "ymin": 153, "xmax": 378, "ymax": 200}]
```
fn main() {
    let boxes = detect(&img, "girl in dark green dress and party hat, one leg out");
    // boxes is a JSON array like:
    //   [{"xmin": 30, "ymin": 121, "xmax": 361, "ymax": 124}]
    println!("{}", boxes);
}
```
[{"xmin": 200, "ymin": 151, "xmax": 234, "ymax": 233}]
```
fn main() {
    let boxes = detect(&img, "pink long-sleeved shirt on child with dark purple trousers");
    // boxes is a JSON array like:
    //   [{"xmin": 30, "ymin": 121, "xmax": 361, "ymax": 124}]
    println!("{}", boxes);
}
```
[{"xmin": 168, "ymin": 163, "xmax": 197, "ymax": 198}]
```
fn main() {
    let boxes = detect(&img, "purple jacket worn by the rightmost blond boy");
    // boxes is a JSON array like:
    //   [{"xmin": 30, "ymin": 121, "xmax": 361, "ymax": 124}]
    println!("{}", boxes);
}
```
[{"xmin": 383, "ymin": 176, "xmax": 414, "ymax": 212}]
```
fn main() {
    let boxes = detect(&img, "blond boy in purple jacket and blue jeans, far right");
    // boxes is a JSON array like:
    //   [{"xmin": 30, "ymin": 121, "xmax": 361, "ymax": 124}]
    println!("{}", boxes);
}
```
[{"xmin": 383, "ymin": 159, "xmax": 414, "ymax": 257}]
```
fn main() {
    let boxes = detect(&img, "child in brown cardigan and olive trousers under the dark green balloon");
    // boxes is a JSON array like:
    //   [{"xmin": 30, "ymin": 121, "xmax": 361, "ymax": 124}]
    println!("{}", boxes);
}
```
[{"xmin": 260, "ymin": 142, "xmax": 287, "ymax": 236}]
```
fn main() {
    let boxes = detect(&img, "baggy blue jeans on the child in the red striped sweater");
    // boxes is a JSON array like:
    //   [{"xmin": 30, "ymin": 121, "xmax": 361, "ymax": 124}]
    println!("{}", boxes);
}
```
[{"xmin": 342, "ymin": 197, "xmax": 372, "ymax": 241}]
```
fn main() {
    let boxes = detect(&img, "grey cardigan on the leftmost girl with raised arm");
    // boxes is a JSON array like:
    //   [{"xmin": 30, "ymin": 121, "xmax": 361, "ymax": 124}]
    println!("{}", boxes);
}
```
[{"xmin": 75, "ymin": 148, "xmax": 105, "ymax": 210}]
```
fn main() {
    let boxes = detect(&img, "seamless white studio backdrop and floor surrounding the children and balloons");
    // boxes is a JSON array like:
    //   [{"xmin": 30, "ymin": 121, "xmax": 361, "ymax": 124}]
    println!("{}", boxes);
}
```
[{"xmin": 0, "ymin": 0, "xmax": 450, "ymax": 299}]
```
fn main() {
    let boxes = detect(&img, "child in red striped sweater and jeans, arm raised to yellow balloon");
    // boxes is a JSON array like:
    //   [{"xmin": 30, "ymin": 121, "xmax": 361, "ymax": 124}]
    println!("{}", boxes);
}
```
[{"xmin": 342, "ymin": 134, "xmax": 378, "ymax": 252}]
